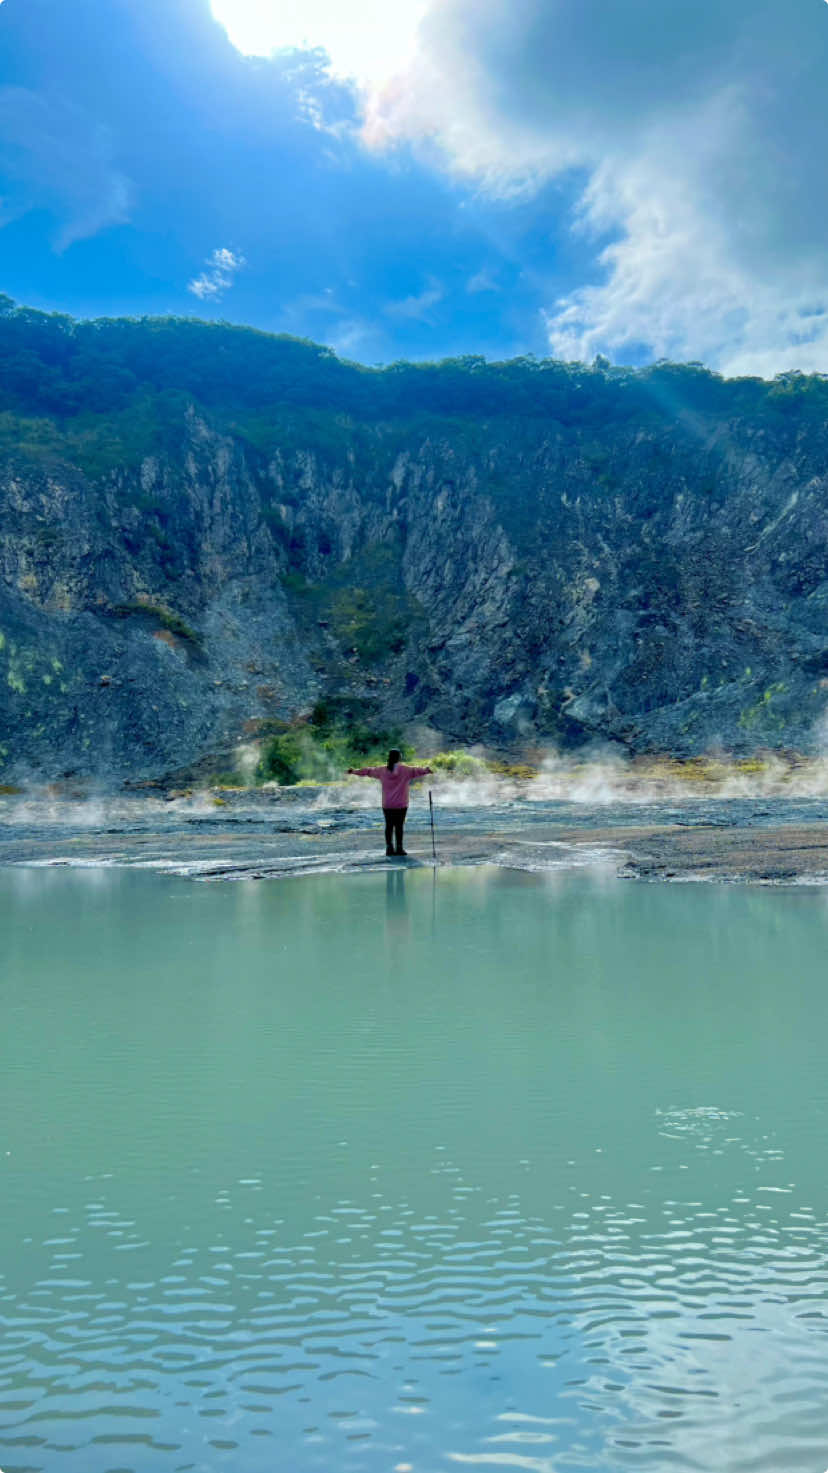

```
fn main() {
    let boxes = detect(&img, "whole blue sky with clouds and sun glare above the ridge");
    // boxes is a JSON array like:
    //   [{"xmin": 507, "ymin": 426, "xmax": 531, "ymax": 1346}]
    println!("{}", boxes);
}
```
[{"xmin": 0, "ymin": 0, "xmax": 828, "ymax": 374}]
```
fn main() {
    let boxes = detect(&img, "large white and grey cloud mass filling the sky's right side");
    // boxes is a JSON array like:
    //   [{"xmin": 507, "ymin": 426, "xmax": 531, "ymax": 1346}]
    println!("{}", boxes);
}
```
[{"xmin": 355, "ymin": 0, "xmax": 828, "ymax": 374}]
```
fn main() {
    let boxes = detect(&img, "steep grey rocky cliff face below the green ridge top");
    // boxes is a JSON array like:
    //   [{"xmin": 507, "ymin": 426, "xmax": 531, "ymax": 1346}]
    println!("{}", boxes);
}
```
[{"xmin": 0, "ymin": 388, "xmax": 828, "ymax": 782}]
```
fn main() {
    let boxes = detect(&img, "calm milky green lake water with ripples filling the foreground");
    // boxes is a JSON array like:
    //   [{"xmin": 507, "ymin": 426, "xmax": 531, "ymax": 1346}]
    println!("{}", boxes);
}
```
[{"xmin": 0, "ymin": 869, "xmax": 828, "ymax": 1473}]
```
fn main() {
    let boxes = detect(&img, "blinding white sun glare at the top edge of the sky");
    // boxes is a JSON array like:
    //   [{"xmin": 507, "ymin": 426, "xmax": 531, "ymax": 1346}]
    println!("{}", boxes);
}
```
[{"xmin": 211, "ymin": 0, "xmax": 427, "ymax": 87}]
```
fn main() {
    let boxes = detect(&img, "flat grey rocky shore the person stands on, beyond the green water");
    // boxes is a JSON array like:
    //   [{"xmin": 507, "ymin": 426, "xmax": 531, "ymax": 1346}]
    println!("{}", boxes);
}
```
[{"xmin": 0, "ymin": 798, "xmax": 828, "ymax": 885}]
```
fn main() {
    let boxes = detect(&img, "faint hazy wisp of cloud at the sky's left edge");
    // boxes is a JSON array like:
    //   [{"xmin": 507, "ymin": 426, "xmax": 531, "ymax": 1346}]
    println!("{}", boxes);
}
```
[{"xmin": 0, "ymin": 87, "xmax": 131, "ymax": 250}]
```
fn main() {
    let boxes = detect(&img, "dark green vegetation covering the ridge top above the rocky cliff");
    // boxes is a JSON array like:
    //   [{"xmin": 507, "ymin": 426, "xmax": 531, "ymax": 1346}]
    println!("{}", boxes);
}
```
[{"xmin": 0, "ymin": 296, "xmax": 828, "ymax": 460}]
